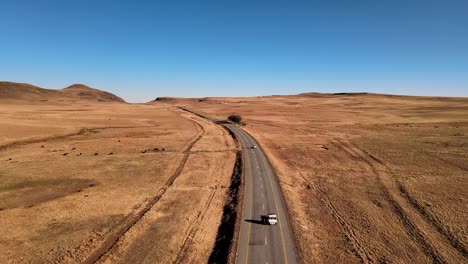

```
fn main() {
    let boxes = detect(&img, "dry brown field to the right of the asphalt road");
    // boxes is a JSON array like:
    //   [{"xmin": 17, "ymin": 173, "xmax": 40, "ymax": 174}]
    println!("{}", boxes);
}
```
[{"xmin": 174, "ymin": 94, "xmax": 468, "ymax": 263}]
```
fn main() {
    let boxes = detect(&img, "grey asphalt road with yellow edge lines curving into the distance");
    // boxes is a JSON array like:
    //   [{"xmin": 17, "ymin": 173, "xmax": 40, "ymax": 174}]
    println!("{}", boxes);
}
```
[{"xmin": 184, "ymin": 108, "xmax": 297, "ymax": 264}]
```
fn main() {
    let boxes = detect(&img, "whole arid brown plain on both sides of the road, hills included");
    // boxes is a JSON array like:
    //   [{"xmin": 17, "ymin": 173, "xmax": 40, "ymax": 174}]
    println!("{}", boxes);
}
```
[{"xmin": 0, "ymin": 82, "xmax": 468, "ymax": 263}]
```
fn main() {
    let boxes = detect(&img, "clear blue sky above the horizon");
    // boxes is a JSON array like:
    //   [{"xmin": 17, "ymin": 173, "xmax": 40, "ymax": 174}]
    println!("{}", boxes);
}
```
[{"xmin": 0, "ymin": 0, "xmax": 468, "ymax": 102}]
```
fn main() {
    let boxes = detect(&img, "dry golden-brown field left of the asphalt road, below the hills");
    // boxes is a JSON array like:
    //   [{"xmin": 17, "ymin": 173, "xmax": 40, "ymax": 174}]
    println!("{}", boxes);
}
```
[{"xmin": 0, "ymin": 100, "xmax": 236, "ymax": 263}]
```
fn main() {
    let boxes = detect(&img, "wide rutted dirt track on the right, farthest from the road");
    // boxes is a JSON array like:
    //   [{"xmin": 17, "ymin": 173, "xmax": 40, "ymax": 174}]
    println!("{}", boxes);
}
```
[{"xmin": 334, "ymin": 140, "xmax": 466, "ymax": 263}]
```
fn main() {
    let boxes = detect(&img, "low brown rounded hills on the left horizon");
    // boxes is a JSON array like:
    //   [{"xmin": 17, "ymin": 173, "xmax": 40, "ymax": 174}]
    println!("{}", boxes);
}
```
[{"xmin": 0, "ymin": 82, "xmax": 125, "ymax": 103}]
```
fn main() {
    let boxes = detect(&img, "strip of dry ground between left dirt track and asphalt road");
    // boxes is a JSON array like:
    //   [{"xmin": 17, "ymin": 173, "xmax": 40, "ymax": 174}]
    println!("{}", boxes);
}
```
[{"xmin": 90, "ymin": 109, "xmax": 235, "ymax": 263}]
